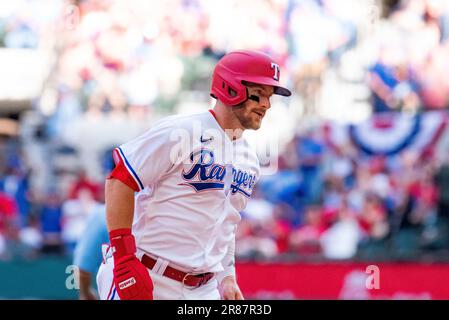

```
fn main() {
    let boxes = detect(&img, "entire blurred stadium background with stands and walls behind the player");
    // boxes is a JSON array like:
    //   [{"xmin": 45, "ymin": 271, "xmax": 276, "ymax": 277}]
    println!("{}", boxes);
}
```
[{"xmin": 0, "ymin": 0, "xmax": 449, "ymax": 299}]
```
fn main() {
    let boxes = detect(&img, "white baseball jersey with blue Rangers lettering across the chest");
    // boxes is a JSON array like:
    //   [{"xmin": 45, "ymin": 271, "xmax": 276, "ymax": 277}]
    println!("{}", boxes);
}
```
[{"xmin": 115, "ymin": 111, "xmax": 260, "ymax": 273}]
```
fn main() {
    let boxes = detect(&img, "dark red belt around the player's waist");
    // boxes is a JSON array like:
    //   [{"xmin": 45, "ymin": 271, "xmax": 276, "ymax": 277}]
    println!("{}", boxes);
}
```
[{"xmin": 142, "ymin": 254, "xmax": 214, "ymax": 287}]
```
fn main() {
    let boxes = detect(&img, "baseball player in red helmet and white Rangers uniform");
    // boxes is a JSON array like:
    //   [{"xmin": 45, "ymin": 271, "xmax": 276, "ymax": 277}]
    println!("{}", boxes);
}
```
[{"xmin": 97, "ymin": 51, "xmax": 291, "ymax": 300}]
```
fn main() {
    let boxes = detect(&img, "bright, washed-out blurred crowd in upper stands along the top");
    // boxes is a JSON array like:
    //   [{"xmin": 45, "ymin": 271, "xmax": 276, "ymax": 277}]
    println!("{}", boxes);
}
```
[{"xmin": 0, "ymin": 0, "xmax": 449, "ymax": 117}]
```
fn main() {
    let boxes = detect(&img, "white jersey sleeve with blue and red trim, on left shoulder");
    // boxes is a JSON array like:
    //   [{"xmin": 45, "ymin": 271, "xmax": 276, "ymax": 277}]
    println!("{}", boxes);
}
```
[{"xmin": 113, "ymin": 121, "xmax": 181, "ymax": 191}]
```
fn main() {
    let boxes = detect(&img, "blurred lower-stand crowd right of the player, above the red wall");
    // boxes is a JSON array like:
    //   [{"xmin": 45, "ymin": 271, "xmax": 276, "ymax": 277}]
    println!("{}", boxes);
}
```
[{"xmin": 236, "ymin": 127, "xmax": 449, "ymax": 259}]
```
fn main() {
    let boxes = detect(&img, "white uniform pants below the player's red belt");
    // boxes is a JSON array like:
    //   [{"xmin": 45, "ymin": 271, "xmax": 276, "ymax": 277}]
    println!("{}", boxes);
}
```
[{"xmin": 97, "ymin": 252, "xmax": 220, "ymax": 300}]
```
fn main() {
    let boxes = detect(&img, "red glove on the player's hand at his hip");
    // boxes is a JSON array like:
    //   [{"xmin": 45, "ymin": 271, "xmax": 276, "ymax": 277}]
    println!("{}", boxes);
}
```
[{"xmin": 109, "ymin": 229, "xmax": 153, "ymax": 300}]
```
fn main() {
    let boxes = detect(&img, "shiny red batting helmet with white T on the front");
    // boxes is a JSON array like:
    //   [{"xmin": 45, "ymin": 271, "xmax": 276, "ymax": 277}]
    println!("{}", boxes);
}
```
[{"xmin": 210, "ymin": 50, "xmax": 292, "ymax": 106}]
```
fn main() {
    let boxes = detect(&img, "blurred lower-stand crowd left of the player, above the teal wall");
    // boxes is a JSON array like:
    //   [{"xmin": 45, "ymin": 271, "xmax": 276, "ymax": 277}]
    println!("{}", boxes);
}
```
[{"xmin": 0, "ymin": 143, "xmax": 105, "ymax": 260}]
